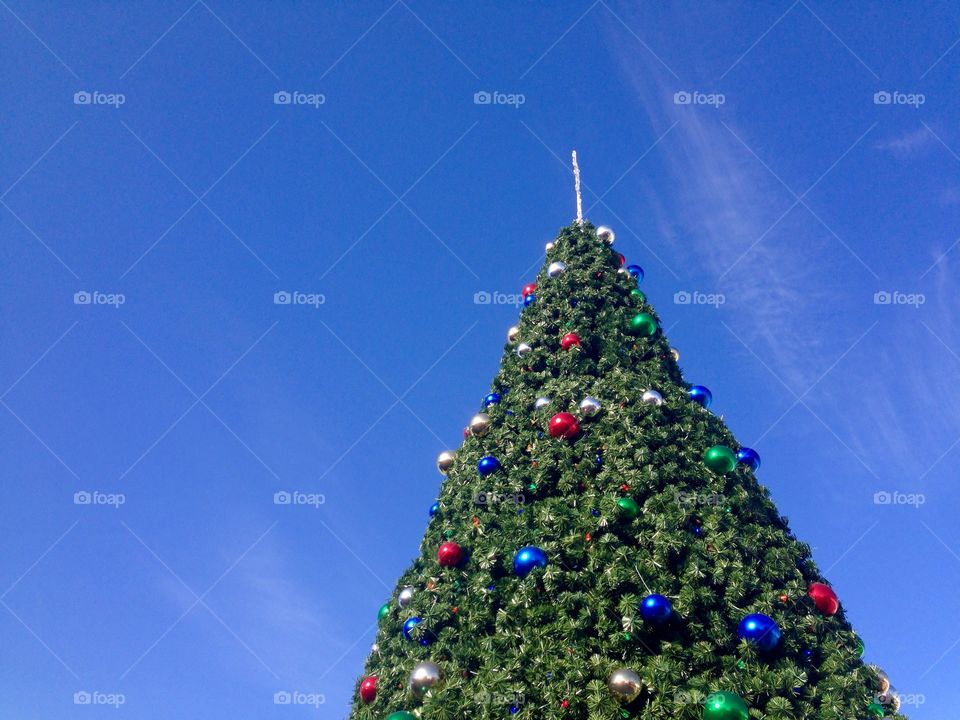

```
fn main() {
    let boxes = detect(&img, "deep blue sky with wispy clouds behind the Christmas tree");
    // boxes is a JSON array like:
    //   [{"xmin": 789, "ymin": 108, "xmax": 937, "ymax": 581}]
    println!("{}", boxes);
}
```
[{"xmin": 0, "ymin": 0, "xmax": 960, "ymax": 718}]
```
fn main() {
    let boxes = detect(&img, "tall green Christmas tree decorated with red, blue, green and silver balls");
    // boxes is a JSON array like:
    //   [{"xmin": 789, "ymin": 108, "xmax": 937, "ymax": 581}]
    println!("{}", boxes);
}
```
[{"xmin": 350, "ymin": 224, "xmax": 897, "ymax": 720}]
